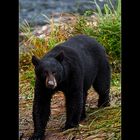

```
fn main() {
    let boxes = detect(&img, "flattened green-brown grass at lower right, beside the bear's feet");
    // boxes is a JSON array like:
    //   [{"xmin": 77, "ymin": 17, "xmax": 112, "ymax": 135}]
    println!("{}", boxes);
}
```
[{"xmin": 63, "ymin": 106, "xmax": 121, "ymax": 140}]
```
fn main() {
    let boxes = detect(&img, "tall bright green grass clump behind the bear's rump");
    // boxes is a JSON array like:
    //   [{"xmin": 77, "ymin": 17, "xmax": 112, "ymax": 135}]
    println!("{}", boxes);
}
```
[{"xmin": 74, "ymin": 0, "xmax": 121, "ymax": 72}]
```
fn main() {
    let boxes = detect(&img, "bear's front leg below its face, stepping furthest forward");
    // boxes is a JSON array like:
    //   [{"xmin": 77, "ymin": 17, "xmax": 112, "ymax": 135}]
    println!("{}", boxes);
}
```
[{"xmin": 29, "ymin": 81, "xmax": 51, "ymax": 140}]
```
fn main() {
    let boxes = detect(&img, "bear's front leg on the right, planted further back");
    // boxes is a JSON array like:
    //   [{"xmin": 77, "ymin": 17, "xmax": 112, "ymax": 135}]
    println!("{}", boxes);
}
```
[{"xmin": 64, "ymin": 90, "xmax": 83, "ymax": 130}]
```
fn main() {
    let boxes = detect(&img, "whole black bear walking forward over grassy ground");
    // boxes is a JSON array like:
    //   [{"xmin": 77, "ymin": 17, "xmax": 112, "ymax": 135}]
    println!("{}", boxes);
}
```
[{"xmin": 30, "ymin": 35, "xmax": 111, "ymax": 140}]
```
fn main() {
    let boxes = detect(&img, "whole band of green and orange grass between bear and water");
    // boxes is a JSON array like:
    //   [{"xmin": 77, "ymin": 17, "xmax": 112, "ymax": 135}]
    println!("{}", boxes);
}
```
[{"xmin": 19, "ymin": 0, "xmax": 121, "ymax": 72}]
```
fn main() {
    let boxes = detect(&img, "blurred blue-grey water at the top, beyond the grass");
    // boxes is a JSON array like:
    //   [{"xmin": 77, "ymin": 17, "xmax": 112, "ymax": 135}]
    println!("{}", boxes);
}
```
[{"xmin": 19, "ymin": 0, "xmax": 117, "ymax": 26}]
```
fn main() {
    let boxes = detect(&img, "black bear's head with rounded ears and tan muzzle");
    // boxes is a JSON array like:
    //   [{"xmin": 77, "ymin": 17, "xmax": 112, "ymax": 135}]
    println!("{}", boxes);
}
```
[{"xmin": 32, "ymin": 52, "xmax": 64, "ymax": 89}]
